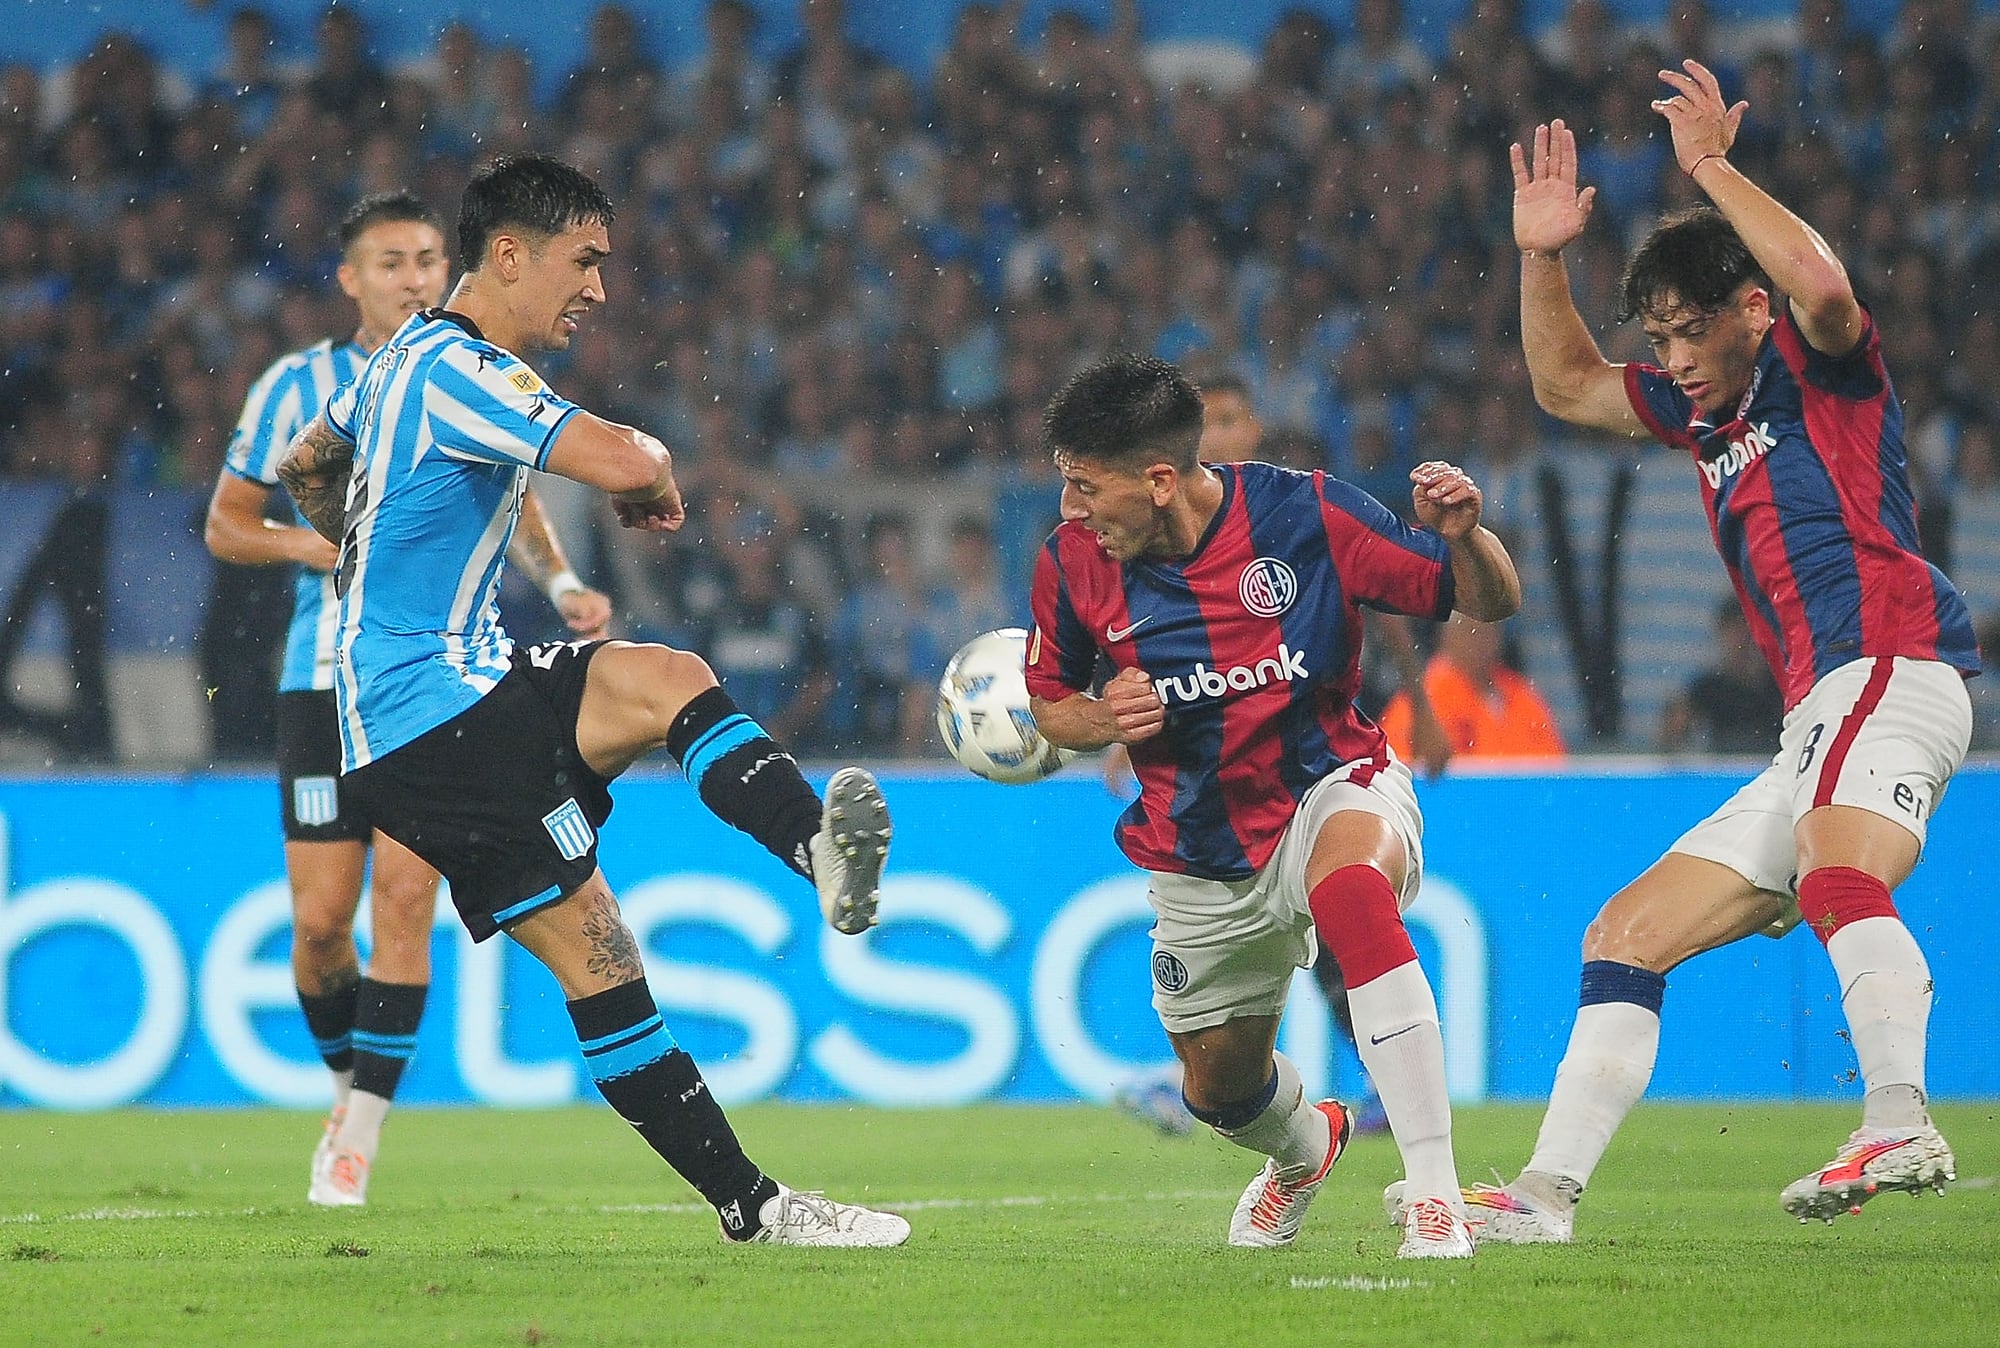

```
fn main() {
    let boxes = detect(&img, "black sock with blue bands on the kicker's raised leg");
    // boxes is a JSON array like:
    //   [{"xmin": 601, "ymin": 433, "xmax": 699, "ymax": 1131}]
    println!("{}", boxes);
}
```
[{"xmin": 666, "ymin": 688, "xmax": 820, "ymax": 880}]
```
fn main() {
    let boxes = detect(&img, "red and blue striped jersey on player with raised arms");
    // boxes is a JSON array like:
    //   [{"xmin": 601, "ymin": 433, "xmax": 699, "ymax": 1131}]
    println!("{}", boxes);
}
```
[{"xmin": 1626, "ymin": 306, "xmax": 1980, "ymax": 710}]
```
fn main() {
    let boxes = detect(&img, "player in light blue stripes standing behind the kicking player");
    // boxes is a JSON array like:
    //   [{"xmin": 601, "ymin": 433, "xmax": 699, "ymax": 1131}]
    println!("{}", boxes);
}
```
[{"xmin": 206, "ymin": 192, "xmax": 610, "ymax": 1206}]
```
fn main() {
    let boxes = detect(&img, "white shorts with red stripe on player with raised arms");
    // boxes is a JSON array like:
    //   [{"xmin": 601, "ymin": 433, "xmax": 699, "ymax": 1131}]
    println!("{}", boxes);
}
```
[{"xmin": 1668, "ymin": 656, "xmax": 1972, "ymax": 894}]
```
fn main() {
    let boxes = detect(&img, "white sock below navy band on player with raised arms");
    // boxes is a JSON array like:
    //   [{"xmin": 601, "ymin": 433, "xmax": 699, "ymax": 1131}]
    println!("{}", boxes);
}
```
[{"xmin": 1528, "ymin": 1002, "xmax": 1660, "ymax": 1184}]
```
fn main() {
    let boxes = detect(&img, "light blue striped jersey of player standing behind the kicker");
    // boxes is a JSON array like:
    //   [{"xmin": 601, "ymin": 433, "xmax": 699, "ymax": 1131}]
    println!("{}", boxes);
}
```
[{"xmin": 224, "ymin": 340, "xmax": 368, "ymax": 692}]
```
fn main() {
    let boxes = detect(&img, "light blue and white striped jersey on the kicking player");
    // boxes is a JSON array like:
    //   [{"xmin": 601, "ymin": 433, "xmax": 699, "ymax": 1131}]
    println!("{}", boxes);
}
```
[{"xmin": 326, "ymin": 310, "xmax": 576, "ymax": 772}]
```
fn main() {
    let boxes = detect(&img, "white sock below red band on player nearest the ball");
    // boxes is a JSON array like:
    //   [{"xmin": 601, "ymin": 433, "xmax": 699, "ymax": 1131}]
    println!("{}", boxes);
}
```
[{"xmin": 1348, "ymin": 960, "xmax": 1458, "ymax": 1208}]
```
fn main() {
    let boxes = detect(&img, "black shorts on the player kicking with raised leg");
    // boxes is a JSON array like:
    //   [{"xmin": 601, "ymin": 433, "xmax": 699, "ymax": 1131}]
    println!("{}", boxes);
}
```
[{"xmin": 342, "ymin": 642, "xmax": 612, "ymax": 940}]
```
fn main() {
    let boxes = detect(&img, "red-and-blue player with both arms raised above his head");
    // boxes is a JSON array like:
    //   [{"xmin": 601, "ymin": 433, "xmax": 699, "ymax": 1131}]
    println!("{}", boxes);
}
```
[{"xmin": 1400, "ymin": 60, "xmax": 1980, "ymax": 1242}]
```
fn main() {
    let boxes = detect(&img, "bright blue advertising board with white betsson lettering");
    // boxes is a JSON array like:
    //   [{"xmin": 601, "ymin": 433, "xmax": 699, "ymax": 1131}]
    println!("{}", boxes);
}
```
[{"xmin": 0, "ymin": 764, "xmax": 2000, "ymax": 1110}]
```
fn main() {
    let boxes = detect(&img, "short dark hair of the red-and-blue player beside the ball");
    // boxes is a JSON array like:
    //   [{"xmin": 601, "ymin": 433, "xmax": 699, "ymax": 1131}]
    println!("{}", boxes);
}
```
[{"xmin": 1042, "ymin": 354, "xmax": 1202, "ymax": 472}]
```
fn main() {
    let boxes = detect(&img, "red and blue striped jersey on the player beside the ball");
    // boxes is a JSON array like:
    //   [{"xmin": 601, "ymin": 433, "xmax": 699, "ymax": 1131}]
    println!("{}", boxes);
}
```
[{"xmin": 1028, "ymin": 464, "xmax": 1452, "ymax": 880}]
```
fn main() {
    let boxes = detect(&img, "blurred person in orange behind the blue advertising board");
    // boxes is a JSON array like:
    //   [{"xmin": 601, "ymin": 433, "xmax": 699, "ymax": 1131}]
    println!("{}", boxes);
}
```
[{"xmin": 1382, "ymin": 614, "xmax": 1564, "ymax": 762}]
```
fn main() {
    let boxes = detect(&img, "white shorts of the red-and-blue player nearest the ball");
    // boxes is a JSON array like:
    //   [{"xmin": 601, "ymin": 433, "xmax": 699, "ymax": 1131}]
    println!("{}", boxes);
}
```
[{"xmin": 1146, "ymin": 756, "xmax": 1424, "ymax": 1034}]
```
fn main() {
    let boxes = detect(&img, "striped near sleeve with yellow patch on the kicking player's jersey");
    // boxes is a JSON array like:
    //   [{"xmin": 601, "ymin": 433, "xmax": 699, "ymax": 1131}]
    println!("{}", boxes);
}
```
[{"xmin": 426, "ymin": 342, "xmax": 576, "ymax": 468}]
